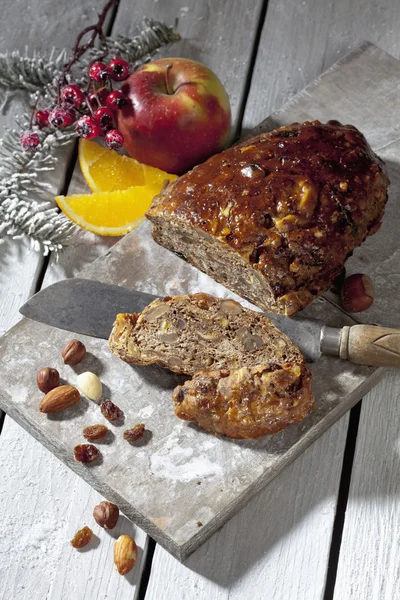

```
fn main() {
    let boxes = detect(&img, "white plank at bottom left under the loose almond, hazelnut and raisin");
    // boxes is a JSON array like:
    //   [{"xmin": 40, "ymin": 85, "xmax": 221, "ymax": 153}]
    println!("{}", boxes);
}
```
[{"xmin": 0, "ymin": 419, "xmax": 146, "ymax": 600}]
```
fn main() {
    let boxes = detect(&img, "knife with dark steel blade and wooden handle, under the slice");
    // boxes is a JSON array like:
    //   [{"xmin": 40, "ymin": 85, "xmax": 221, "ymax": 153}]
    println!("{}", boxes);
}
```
[{"xmin": 20, "ymin": 278, "xmax": 400, "ymax": 367}]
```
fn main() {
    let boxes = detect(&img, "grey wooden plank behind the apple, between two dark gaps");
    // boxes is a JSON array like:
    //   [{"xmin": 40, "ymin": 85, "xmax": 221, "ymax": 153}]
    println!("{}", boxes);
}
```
[{"xmin": 115, "ymin": 0, "xmax": 266, "ymax": 132}]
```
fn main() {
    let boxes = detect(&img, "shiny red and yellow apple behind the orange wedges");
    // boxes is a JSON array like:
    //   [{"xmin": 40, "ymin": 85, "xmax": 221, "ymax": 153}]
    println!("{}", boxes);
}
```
[{"xmin": 117, "ymin": 58, "xmax": 231, "ymax": 175}]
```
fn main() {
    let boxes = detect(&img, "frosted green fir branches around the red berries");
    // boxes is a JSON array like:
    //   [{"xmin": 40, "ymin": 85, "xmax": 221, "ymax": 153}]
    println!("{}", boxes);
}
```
[{"xmin": 0, "ymin": 19, "xmax": 179, "ymax": 254}]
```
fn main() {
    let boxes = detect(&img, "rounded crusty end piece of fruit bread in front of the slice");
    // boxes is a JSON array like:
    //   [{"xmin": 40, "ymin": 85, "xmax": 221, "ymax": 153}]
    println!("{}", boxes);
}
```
[{"xmin": 172, "ymin": 363, "xmax": 314, "ymax": 439}]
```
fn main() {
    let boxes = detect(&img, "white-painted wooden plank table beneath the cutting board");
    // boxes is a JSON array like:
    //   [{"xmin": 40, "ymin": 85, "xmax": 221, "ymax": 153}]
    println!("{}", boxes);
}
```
[{"xmin": 0, "ymin": 0, "xmax": 400, "ymax": 600}]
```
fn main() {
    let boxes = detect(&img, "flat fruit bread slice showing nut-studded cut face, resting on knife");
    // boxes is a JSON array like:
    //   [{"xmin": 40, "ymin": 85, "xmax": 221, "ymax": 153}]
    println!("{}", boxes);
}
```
[{"xmin": 109, "ymin": 293, "xmax": 304, "ymax": 375}]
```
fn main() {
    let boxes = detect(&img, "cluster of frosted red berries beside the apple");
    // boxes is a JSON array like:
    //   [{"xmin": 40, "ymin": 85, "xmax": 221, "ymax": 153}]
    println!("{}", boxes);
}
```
[{"xmin": 20, "ymin": 58, "xmax": 129, "ymax": 151}]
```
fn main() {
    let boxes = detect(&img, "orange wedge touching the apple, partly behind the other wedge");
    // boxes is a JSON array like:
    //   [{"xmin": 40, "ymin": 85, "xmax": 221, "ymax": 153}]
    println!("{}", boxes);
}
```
[{"xmin": 79, "ymin": 139, "xmax": 176, "ymax": 192}]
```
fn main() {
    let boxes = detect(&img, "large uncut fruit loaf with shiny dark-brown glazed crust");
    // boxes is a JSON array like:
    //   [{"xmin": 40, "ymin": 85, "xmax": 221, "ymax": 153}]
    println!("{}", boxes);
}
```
[{"xmin": 147, "ymin": 121, "xmax": 389, "ymax": 315}]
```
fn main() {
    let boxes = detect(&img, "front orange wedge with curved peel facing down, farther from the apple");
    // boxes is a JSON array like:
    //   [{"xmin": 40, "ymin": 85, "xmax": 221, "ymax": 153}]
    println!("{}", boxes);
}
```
[{"xmin": 56, "ymin": 183, "xmax": 160, "ymax": 235}]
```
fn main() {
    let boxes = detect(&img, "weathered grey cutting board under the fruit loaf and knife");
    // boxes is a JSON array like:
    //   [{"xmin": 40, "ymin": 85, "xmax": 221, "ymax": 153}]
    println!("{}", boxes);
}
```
[{"xmin": 0, "ymin": 44, "xmax": 400, "ymax": 560}]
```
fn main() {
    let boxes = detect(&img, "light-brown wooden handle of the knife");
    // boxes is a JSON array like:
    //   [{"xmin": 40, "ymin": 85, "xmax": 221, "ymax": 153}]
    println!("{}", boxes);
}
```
[{"xmin": 339, "ymin": 325, "xmax": 400, "ymax": 367}]
